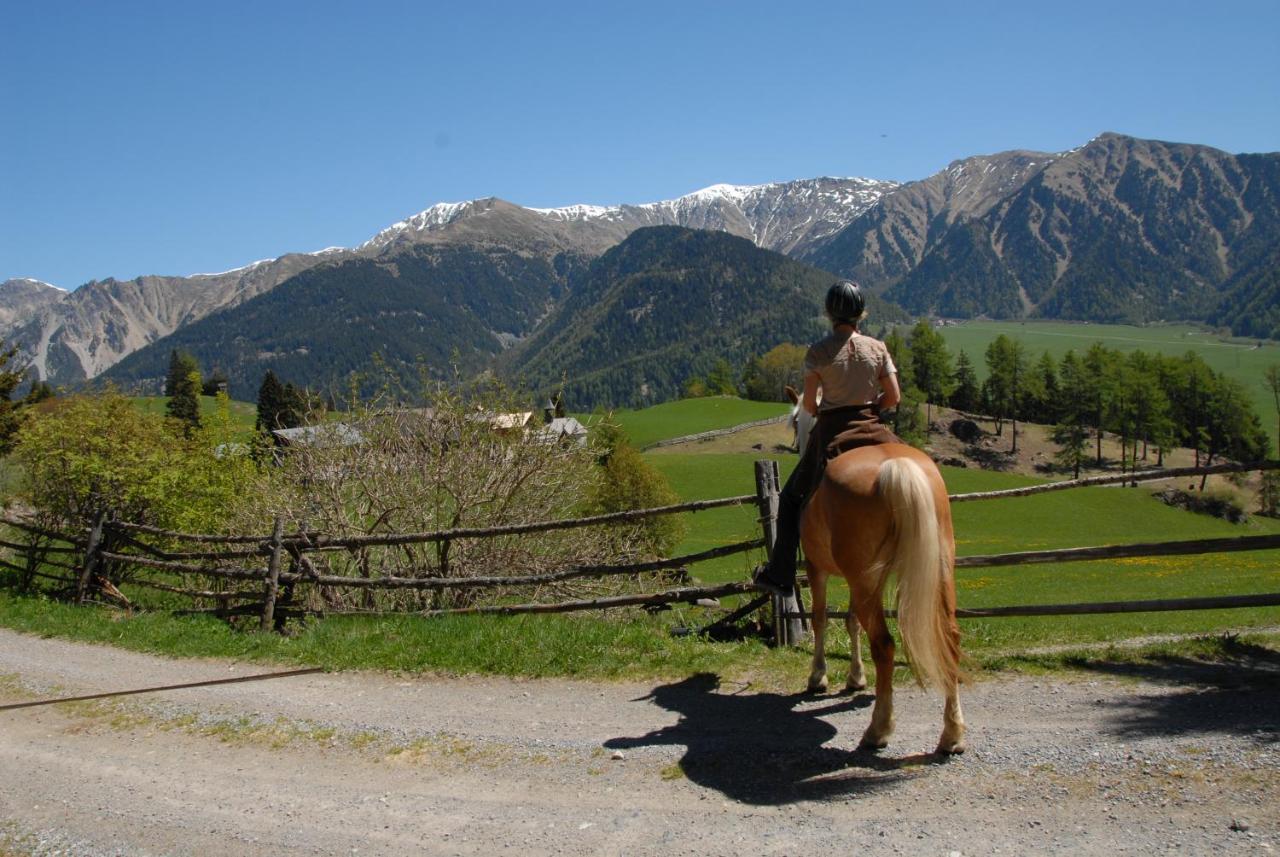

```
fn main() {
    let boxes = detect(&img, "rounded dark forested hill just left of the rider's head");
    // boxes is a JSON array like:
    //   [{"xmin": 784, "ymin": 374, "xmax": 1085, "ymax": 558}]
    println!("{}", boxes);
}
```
[{"xmin": 504, "ymin": 226, "xmax": 904, "ymax": 409}]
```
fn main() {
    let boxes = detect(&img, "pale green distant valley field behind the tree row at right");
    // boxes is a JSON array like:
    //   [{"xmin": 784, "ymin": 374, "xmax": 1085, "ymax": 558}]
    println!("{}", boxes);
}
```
[{"xmin": 911, "ymin": 321, "xmax": 1280, "ymax": 450}]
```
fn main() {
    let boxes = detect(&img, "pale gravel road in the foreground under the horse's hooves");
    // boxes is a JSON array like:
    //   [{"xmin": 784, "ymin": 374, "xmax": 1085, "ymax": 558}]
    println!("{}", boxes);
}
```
[{"xmin": 0, "ymin": 631, "xmax": 1280, "ymax": 857}]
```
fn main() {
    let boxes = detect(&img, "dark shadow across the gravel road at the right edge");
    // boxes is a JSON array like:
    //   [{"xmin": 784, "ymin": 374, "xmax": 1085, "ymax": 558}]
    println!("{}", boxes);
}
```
[{"xmin": 1074, "ymin": 637, "xmax": 1280, "ymax": 743}]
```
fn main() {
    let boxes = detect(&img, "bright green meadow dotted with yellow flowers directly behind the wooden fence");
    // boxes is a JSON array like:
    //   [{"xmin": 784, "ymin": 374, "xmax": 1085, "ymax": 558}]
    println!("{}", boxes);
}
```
[{"xmin": 648, "ymin": 453, "xmax": 1280, "ymax": 652}]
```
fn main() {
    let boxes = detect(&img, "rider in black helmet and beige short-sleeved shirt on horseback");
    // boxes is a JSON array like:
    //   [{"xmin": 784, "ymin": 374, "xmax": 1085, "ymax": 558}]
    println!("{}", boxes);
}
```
[{"xmin": 753, "ymin": 280, "xmax": 902, "ymax": 595}]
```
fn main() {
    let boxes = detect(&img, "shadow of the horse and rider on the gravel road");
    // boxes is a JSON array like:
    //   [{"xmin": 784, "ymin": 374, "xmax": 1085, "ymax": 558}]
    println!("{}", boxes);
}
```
[{"xmin": 604, "ymin": 673, "xmax": 945, "ymax": 806}]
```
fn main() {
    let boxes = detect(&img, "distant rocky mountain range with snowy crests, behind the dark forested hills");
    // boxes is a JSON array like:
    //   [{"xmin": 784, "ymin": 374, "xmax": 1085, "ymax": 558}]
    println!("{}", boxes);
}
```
[{"xmin": 10, "ymin": 133, "xmax": 1280, "ymax": 384}]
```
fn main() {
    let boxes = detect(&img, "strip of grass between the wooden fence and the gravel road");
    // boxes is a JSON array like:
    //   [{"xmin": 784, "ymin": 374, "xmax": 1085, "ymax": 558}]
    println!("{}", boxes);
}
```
[{"xmin": 0, "ymin": 591, "xmax": 1280, "ymax": 691}]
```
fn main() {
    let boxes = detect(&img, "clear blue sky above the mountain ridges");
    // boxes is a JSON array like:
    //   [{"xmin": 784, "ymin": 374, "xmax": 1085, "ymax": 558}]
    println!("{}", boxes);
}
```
[{"xmin": 0, "ymin": 0, "xmax": 1280, "ymax": 288}]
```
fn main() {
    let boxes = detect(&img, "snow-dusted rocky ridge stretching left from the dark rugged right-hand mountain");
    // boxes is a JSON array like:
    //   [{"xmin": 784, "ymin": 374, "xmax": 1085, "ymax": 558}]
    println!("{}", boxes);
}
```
[{"xmin": 0, "ymin": 178, "xmax": 896, "ymax": 384}]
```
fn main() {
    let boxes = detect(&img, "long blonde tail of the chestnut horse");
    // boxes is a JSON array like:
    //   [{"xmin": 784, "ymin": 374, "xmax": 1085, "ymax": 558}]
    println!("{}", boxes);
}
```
[{"xmin": 877, "ymin": 458, "xmax": 959, "ymax": 691}]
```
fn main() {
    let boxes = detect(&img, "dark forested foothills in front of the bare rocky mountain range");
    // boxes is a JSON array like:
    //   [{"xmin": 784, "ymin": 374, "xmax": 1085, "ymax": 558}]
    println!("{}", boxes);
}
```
[{"xmin": 104, "ymin": 226, "xmax": 905, "ymax": 408}]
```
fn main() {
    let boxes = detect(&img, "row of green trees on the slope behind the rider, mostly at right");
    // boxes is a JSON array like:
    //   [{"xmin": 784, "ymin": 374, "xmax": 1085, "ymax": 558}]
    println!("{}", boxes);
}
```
[{"xmin": 727, "ymin": 320, "xmax": 1280, "ymax": 477}]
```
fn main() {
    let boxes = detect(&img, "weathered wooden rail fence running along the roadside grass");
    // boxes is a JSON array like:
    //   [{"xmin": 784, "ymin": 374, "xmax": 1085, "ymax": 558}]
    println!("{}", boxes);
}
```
[{"xmin": 0, "ymin": 460, "xmax": 1280, "ymax": 643}]
